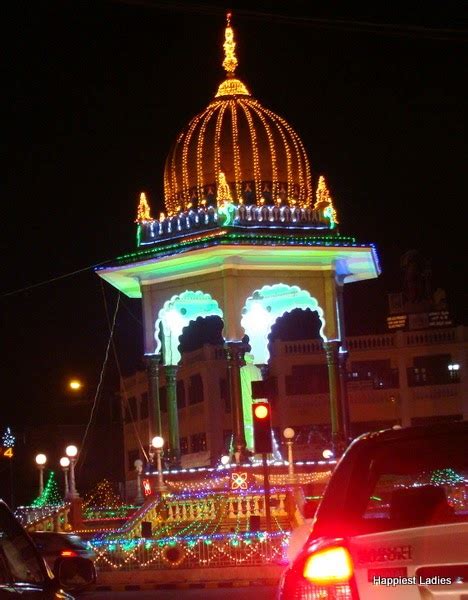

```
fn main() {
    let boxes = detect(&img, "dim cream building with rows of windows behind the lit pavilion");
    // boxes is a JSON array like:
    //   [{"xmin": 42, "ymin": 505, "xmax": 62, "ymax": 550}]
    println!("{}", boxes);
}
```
[{"xmin": 121, "ymin": 326, "xmax": 468, "ymax": 494}]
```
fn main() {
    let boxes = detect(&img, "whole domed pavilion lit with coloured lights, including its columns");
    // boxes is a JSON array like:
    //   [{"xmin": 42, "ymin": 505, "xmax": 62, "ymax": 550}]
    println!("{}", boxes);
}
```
[{"xmin": 97, "ymin": 15, "xmax": 380, "ymax": 464}]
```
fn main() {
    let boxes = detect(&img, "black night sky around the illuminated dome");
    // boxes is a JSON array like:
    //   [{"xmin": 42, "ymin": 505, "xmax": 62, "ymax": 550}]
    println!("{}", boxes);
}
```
[{"xmin": 0, "ymin": 0, "xmax": 468, "ymax": 502}]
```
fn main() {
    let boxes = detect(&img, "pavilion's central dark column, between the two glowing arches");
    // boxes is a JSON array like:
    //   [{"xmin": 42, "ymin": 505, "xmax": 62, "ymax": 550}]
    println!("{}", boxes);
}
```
[{"xmin": 224, "ymin": 341, "xmax": 247, "ymax": 463}]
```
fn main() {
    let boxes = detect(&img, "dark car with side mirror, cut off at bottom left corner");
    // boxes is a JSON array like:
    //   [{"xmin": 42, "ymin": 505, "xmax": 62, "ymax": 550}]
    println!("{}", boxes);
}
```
[{"xmin": 0, "ymin": 499, "xmax": 96, "ymax": 600}]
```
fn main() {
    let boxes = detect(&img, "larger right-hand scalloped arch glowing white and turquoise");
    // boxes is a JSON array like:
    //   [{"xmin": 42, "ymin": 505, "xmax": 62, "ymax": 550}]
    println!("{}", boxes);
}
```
[{"xmin": 241, "ymin": 283, "xmax": 327, "ymax": 364}]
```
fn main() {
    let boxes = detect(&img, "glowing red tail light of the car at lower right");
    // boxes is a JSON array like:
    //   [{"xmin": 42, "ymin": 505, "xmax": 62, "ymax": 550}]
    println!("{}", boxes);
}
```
[{"xmin": 281, "ymin": 540, "xmax": 358, "ymax": 600}]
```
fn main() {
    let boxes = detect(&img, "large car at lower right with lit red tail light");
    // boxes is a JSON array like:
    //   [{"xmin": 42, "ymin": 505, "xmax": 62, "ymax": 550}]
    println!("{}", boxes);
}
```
[{"xmin": 277, "ymin": 421, "xmax": 468, "ymax": 600}]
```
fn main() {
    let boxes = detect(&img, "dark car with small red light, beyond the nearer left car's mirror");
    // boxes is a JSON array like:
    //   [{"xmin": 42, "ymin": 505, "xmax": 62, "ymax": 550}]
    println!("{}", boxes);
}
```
[{"xmin": 29, "ymin": 531, "xmax": 96, "ymax": 571}]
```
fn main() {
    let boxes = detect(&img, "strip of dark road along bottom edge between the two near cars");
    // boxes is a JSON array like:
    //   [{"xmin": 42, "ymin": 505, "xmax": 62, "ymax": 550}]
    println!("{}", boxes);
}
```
[{"xmin": 78, "ymin": 586, "xmax": 276, "ymax": 600}]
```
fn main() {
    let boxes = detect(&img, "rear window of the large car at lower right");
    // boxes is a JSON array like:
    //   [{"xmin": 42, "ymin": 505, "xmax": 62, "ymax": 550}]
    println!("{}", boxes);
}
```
[{"xmin": 348, "ymin": 435, "xmax": 468, "ymax": 533}]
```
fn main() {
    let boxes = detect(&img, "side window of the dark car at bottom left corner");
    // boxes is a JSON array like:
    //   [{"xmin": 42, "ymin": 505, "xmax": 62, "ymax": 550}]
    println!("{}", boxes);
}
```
[{"xmin": 0, "ymin": 505, "xmax": 44, "ymax": 583}]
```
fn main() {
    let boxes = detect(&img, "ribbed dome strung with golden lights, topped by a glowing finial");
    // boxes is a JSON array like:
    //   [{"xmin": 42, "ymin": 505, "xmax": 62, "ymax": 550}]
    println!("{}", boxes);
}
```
[{"xmin": 164, "ymin": 15, "xmax": 313, "ymax": 214}]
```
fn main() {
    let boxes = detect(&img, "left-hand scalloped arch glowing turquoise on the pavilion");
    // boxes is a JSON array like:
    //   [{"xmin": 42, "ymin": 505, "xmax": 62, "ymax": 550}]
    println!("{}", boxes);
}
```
[{"xmin": 154, "ymin": 290, "xmax": 223, "ymax": 365}]
